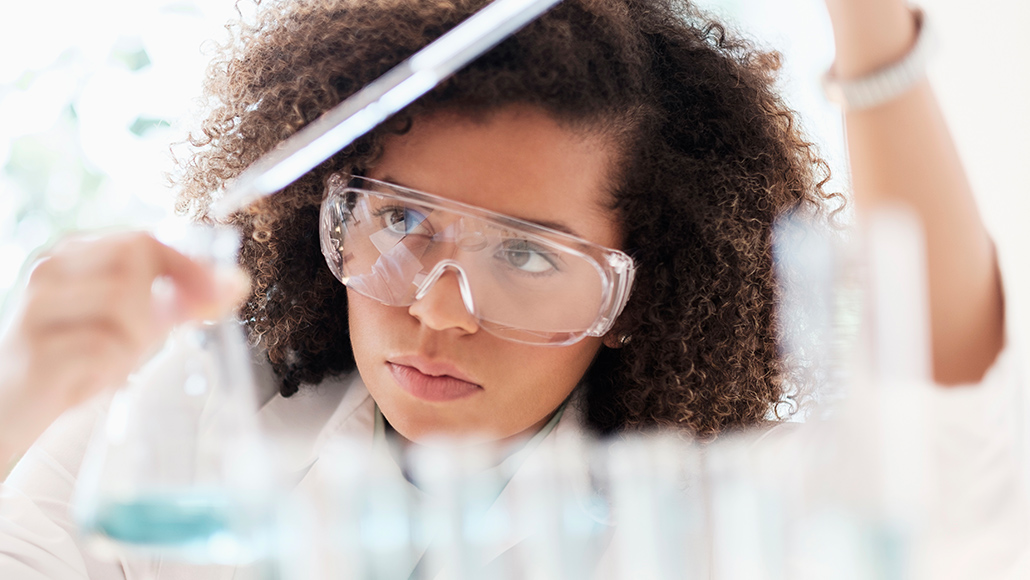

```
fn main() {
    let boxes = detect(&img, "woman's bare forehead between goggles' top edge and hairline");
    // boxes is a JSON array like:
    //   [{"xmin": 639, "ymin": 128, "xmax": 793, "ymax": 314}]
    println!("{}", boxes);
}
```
[{"xmin": 369, "ymin": 107, "xmax": 621, "ymax": 247}]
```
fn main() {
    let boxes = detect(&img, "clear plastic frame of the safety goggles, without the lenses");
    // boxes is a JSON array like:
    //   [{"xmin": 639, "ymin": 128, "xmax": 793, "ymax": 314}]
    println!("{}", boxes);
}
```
[{"xmin": 318, "ymin": 173, "xmax": 636, "ymax": 346}]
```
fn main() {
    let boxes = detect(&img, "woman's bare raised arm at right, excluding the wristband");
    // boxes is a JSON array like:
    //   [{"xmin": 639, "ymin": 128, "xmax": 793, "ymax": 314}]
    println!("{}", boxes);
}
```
[{"xmin": 826, "ymin": 0, "xmax": 1004, "ymax": 384}]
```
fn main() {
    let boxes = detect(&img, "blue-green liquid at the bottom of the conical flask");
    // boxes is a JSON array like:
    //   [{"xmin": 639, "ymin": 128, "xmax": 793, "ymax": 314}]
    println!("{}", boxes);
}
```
[{"xmin": 88, "ymin": 494, "xmax": 235, "ymax": 547}]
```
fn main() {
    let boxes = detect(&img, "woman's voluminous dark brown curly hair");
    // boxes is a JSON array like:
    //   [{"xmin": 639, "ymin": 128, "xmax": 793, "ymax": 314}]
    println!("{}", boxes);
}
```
[{"xmin": 178, "ymin": 0, "xmax": 834, "ymax": 436}]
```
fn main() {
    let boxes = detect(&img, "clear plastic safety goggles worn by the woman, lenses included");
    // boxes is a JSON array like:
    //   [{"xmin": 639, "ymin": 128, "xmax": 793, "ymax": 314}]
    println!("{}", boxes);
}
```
[{"xmin": 319, "ymin": 174, "xmax": 633, "ymax": 346}]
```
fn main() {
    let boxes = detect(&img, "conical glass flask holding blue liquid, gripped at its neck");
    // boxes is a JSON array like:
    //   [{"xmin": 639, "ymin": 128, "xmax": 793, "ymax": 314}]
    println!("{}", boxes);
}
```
[{"xmin": 75, "ymin": 228, "xmax": 273, "ymax": 564}]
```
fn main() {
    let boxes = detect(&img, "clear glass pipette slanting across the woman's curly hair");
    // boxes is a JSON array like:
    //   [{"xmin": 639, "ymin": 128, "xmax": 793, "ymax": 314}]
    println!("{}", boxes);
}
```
[{"xmin": 211, "ymin": 0, "xmax": 560, "ymax": 219}]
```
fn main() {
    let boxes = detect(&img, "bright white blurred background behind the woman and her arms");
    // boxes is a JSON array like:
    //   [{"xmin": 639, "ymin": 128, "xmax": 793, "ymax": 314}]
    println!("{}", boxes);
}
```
[{"xmin": 0, "ymin": 0, "xmax": 1030, "ymax": 364}]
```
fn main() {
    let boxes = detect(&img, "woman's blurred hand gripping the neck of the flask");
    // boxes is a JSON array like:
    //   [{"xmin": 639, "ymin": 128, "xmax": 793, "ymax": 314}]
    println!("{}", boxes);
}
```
[{"xmin": 0, "ymin": 233, "xmax": 248, "ymax": 462}]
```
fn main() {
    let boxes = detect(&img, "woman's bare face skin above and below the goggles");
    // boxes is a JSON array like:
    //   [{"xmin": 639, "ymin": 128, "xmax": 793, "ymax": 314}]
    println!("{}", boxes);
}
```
[{"xmin": 347, "ymin": 103, "xmax": 621, "ymax": 441}]
